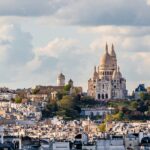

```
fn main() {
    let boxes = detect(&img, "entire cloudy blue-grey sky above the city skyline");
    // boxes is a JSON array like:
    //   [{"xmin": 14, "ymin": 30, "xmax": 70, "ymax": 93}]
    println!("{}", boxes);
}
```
[{"xmin": 0, "ymin": 0, "xmax": 150, "ymax": 92}]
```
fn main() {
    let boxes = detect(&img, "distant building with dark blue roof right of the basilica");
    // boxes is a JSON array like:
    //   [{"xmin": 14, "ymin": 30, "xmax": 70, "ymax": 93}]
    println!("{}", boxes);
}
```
[{"xmin": 134, "ymin": 84, "xmax": 147, "ymax": 99}]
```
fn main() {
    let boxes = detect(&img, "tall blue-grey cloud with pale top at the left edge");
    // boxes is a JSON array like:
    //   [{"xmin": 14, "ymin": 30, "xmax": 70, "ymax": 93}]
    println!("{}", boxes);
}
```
[{"xmin": 0, "ymin": 24, "xmax": 33, "ymax": 65}]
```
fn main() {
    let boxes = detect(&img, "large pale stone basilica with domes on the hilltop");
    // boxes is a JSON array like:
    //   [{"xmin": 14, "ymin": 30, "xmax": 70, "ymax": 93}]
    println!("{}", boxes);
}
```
[{"xmin": 88, "ymin": 44, "xmax": 127, "ymax": 100}]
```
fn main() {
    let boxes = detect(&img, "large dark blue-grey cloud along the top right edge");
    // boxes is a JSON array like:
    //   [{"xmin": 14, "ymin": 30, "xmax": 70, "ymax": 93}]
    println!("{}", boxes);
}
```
[{"xmin": 55, "ymin": 0, "xmax": 150, "ymax": 26}]
